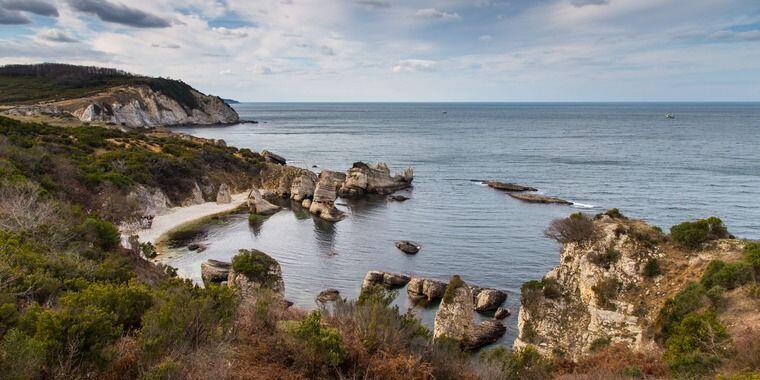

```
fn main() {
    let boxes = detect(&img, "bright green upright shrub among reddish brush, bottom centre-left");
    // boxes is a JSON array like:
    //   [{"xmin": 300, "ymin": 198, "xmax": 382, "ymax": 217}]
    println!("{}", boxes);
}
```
[{"xmin": 295, "ymin": 311, "xmax": 346, "ymax": 367}]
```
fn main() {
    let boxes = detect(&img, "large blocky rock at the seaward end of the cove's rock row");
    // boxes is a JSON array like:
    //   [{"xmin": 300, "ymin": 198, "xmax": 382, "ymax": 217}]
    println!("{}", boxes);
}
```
[{"xmin": 339, "ymin": 162, "xmax": 414, "ymax": 197}]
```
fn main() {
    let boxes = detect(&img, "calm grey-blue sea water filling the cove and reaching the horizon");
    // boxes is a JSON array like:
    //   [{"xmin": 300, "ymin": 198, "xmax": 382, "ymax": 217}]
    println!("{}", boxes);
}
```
[{"xmin": 169, "ymin": 103, "xmax": 760, "ymax": 344}]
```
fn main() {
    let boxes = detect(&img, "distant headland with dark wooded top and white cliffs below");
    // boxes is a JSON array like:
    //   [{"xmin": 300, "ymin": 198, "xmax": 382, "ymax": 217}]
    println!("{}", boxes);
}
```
[{"xmin": 0, "ymin": 64, "xmax": 239, "ymax": 127}]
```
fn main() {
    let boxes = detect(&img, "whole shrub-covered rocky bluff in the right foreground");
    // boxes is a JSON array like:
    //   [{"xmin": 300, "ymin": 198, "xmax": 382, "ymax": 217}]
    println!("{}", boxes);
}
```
[{"xmin": 514, "ymin": 210, "xmax": 760, "ymax": 378}]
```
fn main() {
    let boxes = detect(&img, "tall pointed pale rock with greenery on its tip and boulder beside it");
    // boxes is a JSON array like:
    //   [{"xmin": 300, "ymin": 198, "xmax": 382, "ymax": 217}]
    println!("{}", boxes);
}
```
[{"xmin": 433, "ymin": 276, "xmax": 507, "ymax": 350}]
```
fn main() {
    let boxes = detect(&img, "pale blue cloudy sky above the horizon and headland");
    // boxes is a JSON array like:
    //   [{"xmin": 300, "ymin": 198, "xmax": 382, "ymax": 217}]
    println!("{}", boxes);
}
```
[{"xmin": 0, "ymin": 0, "xmax": 760, "ymax": 102}]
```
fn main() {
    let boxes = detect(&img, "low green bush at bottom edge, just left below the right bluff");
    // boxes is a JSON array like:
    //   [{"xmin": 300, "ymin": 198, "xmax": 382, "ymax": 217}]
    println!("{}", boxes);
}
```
[{"xmin": 480, "ymin": 346, "xmax": 553, "ymax": 380}]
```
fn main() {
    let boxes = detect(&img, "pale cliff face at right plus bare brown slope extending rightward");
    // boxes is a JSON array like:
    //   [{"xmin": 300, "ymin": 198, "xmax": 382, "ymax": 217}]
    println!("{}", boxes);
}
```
[{"xmin": 514, "ymin": 215, "xmax": 740, "ymax": 359}]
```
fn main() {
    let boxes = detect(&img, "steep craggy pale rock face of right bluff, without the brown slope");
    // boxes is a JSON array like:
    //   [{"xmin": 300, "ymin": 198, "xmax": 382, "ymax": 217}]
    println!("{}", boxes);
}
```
[{"xmin": 514, "ymin": 216, "xmax": 665, "ymax": 359}]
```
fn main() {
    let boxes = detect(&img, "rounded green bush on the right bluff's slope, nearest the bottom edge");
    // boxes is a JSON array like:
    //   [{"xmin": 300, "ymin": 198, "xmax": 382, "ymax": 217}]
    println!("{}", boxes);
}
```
[{"xmin": 664, "ymin": 312, "xmax": 730, "ymax": 378}]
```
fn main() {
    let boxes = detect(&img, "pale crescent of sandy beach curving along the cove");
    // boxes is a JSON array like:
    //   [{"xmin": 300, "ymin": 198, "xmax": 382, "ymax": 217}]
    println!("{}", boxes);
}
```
[{"xmin": 136, "ymin": 191, "xmax": 248, "ymax": 245}]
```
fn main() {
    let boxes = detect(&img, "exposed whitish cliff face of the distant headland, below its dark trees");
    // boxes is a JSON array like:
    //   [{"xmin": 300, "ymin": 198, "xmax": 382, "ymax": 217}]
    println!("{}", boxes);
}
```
[{"xmin": 46, "ymin": 84, "xmax": 240, "ymax": 128}]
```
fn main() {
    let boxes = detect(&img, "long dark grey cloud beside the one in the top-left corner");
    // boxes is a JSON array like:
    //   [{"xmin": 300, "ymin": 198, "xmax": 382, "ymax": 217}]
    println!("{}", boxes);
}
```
[{"xmin": 68, "ymin": 0, "xmax": 171, "ymax": 28}]
